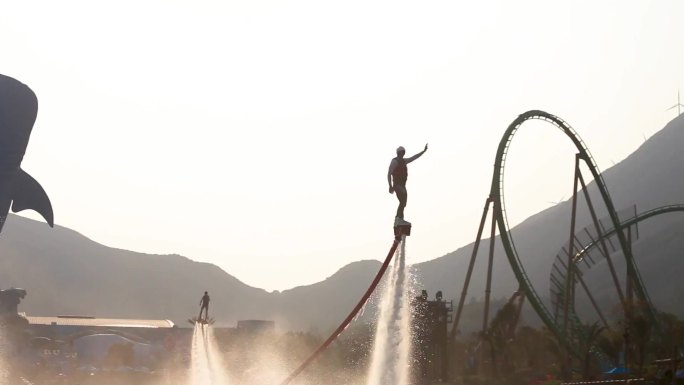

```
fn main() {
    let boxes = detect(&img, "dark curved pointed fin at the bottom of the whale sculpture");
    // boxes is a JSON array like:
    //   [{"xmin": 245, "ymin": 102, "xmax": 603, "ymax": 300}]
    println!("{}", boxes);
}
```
[{"xmin": 12, "ymin": 169, "xmax": 55, "ymax": 227}]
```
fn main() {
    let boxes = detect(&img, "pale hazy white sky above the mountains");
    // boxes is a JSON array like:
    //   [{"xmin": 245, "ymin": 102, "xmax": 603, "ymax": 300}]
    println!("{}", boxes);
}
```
[{"xmin": 0, "ymin": 0, "xmax": 684, "ymax": 290}]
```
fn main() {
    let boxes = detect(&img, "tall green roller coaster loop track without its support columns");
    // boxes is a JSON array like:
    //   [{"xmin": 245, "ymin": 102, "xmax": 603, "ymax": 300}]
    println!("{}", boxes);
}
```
[{"xmin": 490, "ymin": 110, "xmax": 656, "ymax": 351}]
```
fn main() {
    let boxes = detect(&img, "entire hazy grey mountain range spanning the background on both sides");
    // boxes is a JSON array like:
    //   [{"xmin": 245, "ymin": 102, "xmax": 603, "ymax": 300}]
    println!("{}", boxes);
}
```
[{"xmin": 0, "ymin": 116, "xmax": 684, "ymax": 330}]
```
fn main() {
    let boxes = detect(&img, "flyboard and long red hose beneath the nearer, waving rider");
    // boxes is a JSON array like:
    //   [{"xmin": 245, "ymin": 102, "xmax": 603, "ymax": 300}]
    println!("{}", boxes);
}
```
[{"xmin": 280, "ymin": 218, "xmax": 411, "ymax": 385}]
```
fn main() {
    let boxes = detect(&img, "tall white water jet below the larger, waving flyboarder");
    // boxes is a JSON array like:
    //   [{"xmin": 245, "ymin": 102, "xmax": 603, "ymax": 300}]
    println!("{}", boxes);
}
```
[{"xmin": 366, "ymin": 237, "xmax": 411, "ymax": 385}]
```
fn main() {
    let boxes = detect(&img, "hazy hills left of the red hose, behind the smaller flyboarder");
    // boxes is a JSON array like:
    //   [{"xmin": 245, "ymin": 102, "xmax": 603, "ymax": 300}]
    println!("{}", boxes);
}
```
[{"xmin": 0, "ymin": 215, "xmax": 390, "ymax": 330}]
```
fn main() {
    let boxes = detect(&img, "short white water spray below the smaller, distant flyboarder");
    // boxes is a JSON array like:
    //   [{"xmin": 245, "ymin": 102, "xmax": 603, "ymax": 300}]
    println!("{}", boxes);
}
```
[{"xmin": 188, "ymin": 323, "xmax": 230, "ymax": 385}]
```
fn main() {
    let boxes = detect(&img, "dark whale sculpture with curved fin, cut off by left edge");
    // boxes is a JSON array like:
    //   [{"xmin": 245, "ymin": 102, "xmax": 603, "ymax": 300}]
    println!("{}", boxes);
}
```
[{"xmin": 0, "ymin": 75, "xmax": 54, "ymax": 232}]
